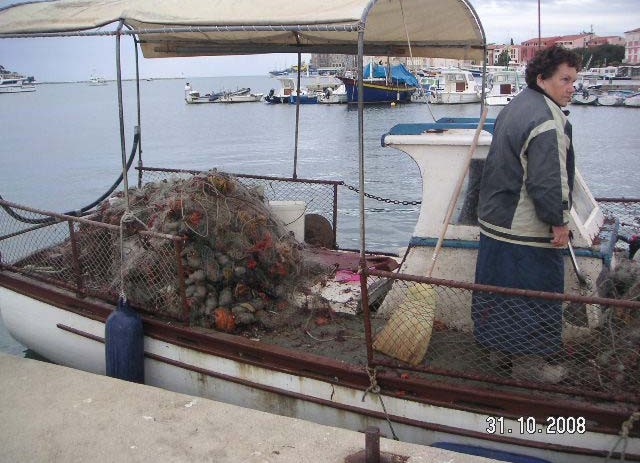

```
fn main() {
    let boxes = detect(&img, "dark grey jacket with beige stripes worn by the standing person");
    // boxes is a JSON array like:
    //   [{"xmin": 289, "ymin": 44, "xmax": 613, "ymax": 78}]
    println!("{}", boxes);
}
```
[{"xmin": 478, "ymin": 88, "xmax": 575, "ymax": 247}]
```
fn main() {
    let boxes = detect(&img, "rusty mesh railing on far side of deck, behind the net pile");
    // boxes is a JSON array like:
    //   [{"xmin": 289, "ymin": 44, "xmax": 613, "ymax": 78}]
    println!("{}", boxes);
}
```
[{"xmin": 137, "ymin": 167, "xmax": 344, "ymax": 248}]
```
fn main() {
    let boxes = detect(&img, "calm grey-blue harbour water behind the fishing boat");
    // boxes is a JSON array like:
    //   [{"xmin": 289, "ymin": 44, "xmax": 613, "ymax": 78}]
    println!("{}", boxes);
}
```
[{"xmin": 0, "ymin": 76, "xmax": 640, "ymax": 355}]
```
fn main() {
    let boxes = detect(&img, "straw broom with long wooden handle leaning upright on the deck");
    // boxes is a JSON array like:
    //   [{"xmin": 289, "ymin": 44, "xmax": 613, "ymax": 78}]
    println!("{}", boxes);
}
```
[{"xmin": 373, "ymin": 107, "xmax": 487, "ymax": 366}]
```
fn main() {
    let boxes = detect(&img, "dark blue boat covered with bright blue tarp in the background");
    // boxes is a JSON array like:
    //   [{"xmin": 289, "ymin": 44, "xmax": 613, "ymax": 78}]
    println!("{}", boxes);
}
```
[{"xmin": 339, "ymin": 63, "xmax": 419, "ymax": 103}]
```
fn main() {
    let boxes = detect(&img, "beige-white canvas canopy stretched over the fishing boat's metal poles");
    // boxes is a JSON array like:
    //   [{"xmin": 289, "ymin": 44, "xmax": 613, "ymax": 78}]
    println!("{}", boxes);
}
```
[{"xmin": 0, "ymin": 0, "xmax": 485, "ymax": 61}]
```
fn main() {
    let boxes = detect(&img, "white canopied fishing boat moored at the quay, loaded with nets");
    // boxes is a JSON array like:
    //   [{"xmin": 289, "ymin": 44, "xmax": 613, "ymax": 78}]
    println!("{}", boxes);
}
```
[{"xmin": 0, "ymin": 0, "xmax": 640, "ymax": 463}]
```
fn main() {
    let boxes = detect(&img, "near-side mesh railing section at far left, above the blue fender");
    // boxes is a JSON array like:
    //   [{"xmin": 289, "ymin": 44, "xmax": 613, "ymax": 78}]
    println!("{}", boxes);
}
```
[{"xmin": 0, "ymin": 198, "xmax": 190, "ymax": 322}]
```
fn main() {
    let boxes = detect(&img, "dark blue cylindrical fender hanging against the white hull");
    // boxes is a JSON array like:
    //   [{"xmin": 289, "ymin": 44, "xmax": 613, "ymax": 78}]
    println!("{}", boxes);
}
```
[{"xmin": 104, "ymin": 297, "xmax": 144, "ymax": 384}]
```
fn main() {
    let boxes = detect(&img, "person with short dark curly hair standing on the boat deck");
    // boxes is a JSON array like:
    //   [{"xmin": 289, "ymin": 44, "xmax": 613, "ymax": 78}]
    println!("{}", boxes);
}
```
[{"xmin": 472, "ymin": 46, "xmax": 580, "ymax": 383}]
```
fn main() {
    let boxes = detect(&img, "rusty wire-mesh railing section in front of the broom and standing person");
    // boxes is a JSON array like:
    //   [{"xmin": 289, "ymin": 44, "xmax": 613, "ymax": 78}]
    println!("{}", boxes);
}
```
[{"xmin": 362, "ymin": 269, "xmax": 640, "ymax": 408}]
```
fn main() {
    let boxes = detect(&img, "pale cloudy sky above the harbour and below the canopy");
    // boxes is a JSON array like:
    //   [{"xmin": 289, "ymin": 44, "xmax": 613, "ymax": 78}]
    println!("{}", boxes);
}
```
[{"xmin": 0, "ymin": 0, "xmax": 640, "ymax": 82}]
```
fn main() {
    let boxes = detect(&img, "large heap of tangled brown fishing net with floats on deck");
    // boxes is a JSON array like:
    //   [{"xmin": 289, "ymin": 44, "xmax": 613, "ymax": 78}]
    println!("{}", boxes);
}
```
[{"xmin": 89, "ymin": 170, "xmax": 333, "ymax": 331}]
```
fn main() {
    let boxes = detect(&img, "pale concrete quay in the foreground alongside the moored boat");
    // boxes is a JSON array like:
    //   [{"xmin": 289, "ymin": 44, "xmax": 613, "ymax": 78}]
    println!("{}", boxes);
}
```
[{"xmin": 0, "ymin": 354, "xmax": 495, "ymax": 463}]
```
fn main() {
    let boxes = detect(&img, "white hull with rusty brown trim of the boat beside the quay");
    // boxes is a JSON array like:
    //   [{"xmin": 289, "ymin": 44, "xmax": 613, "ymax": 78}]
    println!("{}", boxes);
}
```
[{"xmin": 0, "ymin": 285, "xmax": 640, "ymax": 462}]
